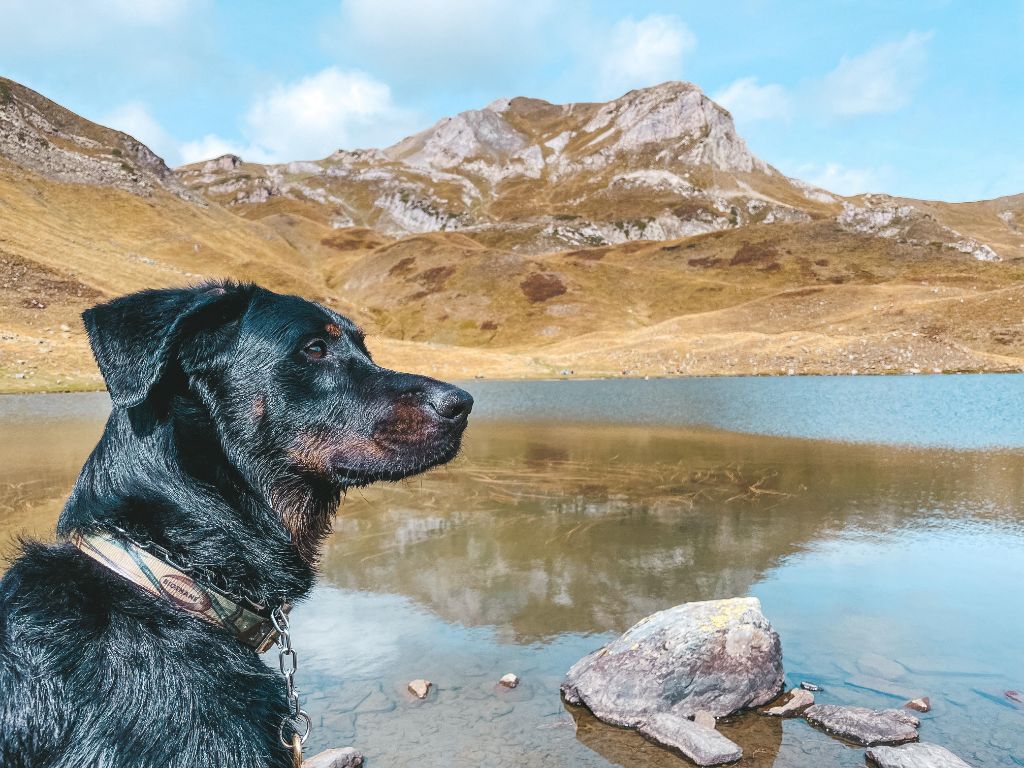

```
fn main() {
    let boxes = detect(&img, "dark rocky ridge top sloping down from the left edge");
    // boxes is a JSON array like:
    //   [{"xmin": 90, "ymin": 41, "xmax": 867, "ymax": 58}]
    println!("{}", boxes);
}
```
[{"xmin": 0, "ymin": 78, "xmax": 192, "ymax": 200}]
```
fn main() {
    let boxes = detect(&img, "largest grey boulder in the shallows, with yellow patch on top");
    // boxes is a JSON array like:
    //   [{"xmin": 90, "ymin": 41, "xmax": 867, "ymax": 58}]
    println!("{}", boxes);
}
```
[{"xmin": 562, "ymin": 597, "xmax": 782, "ymax": 728}]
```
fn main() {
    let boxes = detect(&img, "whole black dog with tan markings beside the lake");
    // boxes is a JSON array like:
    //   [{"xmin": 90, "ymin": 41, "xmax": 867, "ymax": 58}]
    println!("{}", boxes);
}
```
[{"xmin": 0, "ymin": 284, "xmax": 472, "ymax": 768}]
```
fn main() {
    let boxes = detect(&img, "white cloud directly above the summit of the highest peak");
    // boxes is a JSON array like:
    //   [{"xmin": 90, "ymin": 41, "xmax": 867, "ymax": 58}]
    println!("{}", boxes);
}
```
[{"xmin": 594, "ymin": 15, "xmax": 696, "ymax": 96}]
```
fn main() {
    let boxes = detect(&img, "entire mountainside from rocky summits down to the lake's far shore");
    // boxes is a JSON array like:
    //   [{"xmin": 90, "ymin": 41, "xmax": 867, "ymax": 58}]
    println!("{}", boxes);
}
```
[{"xmin": 0, "ymin": 80, "xmax": 1024, "ymax": 391}]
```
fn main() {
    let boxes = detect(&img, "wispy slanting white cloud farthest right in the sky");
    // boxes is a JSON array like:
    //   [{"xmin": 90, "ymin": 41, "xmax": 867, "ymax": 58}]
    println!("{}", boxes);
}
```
[{"xmin": 821, "ymin": 32, "xmax": 932, "ymax": 116}]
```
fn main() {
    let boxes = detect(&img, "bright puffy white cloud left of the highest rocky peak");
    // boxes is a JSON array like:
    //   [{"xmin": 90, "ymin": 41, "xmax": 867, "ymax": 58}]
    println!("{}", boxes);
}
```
[{"xmin": 245, "ymin": 67, "xmax": 412, "ymax": 161}]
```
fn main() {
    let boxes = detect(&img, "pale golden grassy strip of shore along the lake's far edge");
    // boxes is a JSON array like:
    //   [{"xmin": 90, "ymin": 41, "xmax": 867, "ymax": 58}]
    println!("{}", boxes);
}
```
[{"xmin": 0, "ymin": 332, "xmax": 1024, "ymax": 394}]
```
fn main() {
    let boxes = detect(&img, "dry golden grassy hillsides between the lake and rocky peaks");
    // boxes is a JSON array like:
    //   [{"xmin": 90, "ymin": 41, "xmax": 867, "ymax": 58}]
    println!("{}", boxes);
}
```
[{"xmin": 0, "ymin": 162, "xmax": 1024, "ymax": 391}]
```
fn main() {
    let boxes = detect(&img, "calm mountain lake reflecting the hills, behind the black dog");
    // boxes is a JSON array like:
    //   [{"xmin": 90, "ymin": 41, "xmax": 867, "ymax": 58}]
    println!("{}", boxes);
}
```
[{"xmin": 0, "ymin": 375, "xmax": 1024, "ymax": 768}]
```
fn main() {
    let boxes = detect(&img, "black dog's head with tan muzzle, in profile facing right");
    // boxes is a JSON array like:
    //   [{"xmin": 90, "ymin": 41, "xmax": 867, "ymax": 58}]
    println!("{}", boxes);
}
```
[{"xmin": 83, "ymin": 283, "xmax": 473, "ymax": 552}]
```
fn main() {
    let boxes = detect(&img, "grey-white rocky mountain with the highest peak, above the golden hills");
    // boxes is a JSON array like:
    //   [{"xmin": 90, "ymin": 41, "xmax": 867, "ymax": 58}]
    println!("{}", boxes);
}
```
[{"xmin": 177, "ymin": 82, "xmax": 1024, "ymax": 260}]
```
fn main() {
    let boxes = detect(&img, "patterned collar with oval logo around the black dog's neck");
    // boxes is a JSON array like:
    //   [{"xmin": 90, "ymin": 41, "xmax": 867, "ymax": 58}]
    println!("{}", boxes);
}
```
[{"xmin": 71, "ymin": 531, "xmax": 278, "ymax": 653}]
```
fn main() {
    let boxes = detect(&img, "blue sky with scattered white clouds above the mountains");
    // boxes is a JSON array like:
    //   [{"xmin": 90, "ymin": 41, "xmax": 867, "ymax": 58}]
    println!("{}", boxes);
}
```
[{"xmin": 0, "ymin": 0, "xmax": 1024, "ymax": 200}]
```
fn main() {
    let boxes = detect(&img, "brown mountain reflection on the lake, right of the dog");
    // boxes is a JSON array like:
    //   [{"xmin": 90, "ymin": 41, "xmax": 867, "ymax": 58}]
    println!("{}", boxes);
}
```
[{"xmin": 324, "ymin": 423, "xmax": 1024, "ymax": 641}]
